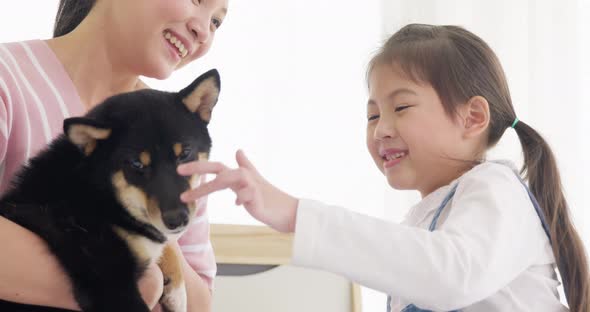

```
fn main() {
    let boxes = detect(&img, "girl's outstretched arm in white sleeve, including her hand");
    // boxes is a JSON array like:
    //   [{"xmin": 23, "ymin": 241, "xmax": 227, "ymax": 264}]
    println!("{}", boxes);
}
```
[{"xmin": 178, "ymin": 151, "xmax": 551, "ymax": 311}]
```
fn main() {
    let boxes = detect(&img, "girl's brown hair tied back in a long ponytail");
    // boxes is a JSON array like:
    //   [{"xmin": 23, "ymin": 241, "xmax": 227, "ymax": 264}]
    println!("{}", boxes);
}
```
[{"xmin": 367, "ymin": 24, "xmax": 590, "ymax": 312}]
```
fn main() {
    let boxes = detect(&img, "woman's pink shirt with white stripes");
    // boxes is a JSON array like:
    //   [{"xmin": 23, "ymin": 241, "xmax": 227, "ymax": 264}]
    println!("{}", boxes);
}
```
[{"xmin": 0, "ymin": 40, "xmax": 217, "ymax": 288}]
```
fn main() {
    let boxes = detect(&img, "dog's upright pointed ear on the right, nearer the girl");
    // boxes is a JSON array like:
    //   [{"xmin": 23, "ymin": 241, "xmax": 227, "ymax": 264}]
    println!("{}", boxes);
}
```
[{"xmin": 179, "ymin": 69, "xmax": 221, "ymax": 123}]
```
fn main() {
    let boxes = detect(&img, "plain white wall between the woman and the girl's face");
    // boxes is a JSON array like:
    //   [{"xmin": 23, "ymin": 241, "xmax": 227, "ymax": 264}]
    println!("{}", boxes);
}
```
[{"xmin": 150, "ymin": 0, "xmax": 385, "ymax": 311}]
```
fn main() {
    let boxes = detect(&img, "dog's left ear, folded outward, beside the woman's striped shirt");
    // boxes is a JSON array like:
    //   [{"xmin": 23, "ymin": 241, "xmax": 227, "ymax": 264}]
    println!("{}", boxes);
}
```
[{"xmin": 64, "ymin": 117, "xmax": 111, "ymax": 156}]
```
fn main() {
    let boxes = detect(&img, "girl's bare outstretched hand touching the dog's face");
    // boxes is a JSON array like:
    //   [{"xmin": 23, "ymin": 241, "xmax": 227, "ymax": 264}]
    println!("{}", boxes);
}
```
[{"xmin": 178, "ymin": 150, "xmax": 298, "ymax": 232}]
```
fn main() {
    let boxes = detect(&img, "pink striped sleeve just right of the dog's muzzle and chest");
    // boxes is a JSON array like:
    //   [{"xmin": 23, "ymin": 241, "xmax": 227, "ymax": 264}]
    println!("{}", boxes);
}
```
[{"xmin": 178, "ymin": 174, "xmax": 217, "ymax": 289}]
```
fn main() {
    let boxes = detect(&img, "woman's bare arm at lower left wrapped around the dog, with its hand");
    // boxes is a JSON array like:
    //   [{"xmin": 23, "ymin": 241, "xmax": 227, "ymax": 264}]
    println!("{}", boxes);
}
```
[{"xmin": 0, "ymin": 217, "xmax": 163, "ymax": 310}]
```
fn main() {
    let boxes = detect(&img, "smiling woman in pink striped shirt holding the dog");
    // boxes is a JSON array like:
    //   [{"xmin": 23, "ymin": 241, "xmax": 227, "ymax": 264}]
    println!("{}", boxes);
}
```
[{"xmin": 0, "ymin": 0, "xmax": 228, "ymax": 311}]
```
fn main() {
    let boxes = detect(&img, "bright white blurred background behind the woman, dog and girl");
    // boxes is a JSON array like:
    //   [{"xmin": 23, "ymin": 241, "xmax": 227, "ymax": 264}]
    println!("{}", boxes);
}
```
[{"xmin": 0, "ymin": 0, "xmax": 590, "ymax": 311}]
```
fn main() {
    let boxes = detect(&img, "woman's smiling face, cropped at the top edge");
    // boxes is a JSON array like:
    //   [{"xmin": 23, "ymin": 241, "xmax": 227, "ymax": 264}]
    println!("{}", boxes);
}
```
[{"xmin": 96, "ymin": 0, "xmax": 228, "ymax": 79}]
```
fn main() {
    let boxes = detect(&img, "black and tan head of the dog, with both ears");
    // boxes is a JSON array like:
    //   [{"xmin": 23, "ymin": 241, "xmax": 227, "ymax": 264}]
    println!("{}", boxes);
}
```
[{"xmin": 64, "ymin": 70, "xmax": 220, "ymax": 235}]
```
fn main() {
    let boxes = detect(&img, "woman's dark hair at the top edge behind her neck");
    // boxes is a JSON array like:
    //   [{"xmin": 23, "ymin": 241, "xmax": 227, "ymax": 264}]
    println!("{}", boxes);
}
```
[{"xmin": 53, "ymin": 0, "xmax": 96, "ymax": 38}]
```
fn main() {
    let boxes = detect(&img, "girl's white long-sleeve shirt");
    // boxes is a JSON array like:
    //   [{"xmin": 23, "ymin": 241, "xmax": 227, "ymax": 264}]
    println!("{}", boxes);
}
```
[{"xmin": 292, "ymin": 162, "xmax": 568, "ymax": 312}]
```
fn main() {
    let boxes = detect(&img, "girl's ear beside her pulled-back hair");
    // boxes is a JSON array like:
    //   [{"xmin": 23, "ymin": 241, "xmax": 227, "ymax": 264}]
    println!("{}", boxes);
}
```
[{"xmin": 460, "ymin": 96, "xmax": 490, "ymax": 138}]
